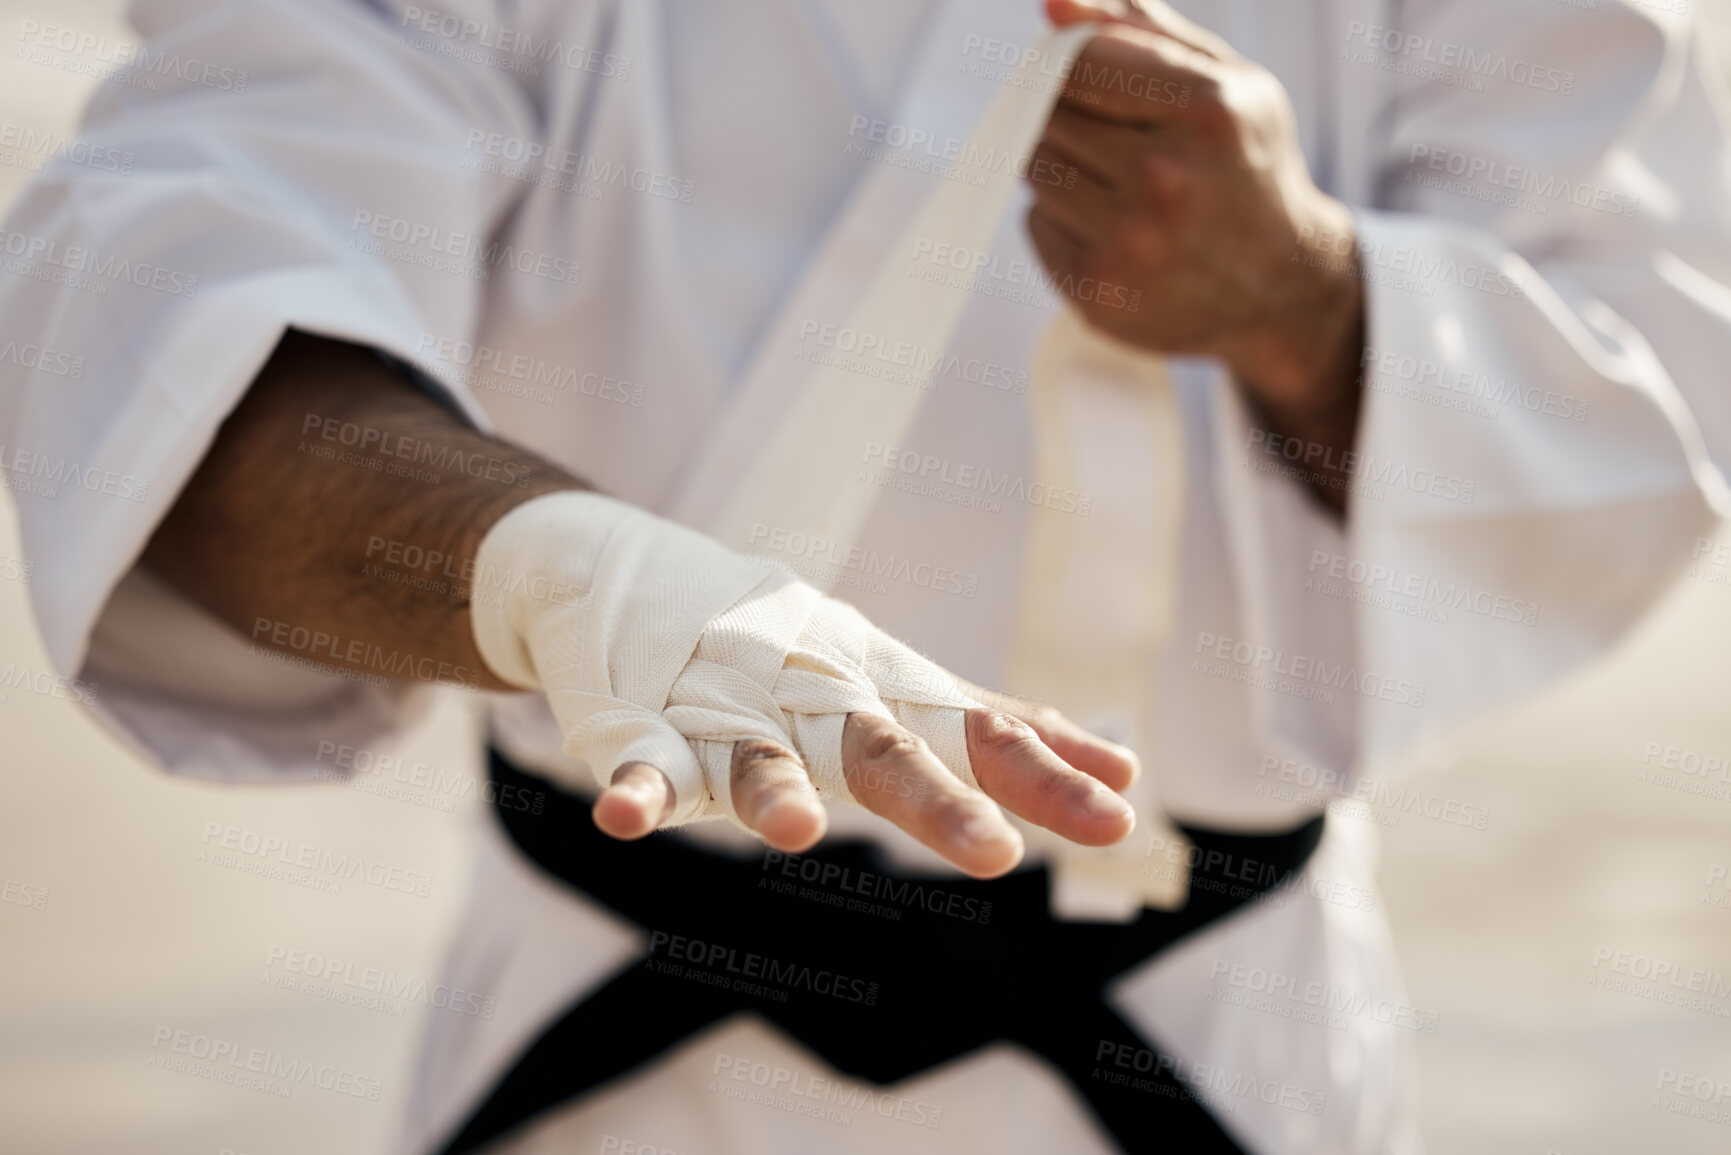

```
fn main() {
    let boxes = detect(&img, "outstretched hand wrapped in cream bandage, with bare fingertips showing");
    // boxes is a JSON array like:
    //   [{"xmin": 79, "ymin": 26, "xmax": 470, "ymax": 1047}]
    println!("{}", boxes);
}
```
[{"xmin": 473, "ymin": 492, "xmax": 1137, "ymax": 876}]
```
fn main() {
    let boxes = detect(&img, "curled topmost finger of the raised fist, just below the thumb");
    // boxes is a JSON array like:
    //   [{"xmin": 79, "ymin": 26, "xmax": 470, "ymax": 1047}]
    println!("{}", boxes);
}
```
[{"xmin": 1059, "ymin": 24, "xmax": 1219, "ymax": 125}]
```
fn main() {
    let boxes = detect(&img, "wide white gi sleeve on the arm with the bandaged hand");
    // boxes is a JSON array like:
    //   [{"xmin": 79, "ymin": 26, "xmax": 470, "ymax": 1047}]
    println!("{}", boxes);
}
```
[{"xmin": 0, "ymin": 0, "xmax": 537, "ymax": 778}]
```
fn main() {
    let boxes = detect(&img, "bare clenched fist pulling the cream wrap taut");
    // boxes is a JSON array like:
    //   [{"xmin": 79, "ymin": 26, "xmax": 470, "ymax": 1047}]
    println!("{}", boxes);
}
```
[{"xmin": 1028, "ymin": 0, "xmax": 1364, "ymax": 502}]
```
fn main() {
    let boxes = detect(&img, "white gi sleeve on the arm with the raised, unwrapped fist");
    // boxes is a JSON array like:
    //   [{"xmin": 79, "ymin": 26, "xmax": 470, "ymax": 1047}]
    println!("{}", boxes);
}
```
[{"xmin": 1224, "ymin": 0, "xmax": 1731, "ymax": 786}]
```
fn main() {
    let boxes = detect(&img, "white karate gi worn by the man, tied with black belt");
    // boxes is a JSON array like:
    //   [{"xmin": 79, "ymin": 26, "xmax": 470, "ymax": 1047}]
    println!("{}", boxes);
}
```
[{"xmin": 0, "ymin": 0, "xmax": 1731, "ymax": 1155}]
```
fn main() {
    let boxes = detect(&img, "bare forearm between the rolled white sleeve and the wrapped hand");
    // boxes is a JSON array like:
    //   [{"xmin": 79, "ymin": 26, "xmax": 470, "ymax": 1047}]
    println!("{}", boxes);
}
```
[{"xmin": 144, "ymin": 332, "xmax": 589, "ymax": 689}]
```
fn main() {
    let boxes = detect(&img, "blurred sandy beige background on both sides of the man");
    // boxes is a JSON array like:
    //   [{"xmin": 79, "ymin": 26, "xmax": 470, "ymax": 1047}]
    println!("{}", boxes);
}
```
[{"xmin": 0, "ymin": 0, "xmax": 1731, "ymax": 1155}]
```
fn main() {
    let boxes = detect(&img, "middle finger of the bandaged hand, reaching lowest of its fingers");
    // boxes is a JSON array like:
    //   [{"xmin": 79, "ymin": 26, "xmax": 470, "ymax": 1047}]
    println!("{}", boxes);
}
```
[{"xmin": 841, "ymin": 713, "xmax": 1023, "ymax": 878}]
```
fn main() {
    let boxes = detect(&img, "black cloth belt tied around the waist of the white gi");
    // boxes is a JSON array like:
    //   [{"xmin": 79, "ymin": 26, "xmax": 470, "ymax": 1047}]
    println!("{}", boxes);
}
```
[{"xmin": 445, "ymin": 750, "xmax": 1322, "ymax": 1155}]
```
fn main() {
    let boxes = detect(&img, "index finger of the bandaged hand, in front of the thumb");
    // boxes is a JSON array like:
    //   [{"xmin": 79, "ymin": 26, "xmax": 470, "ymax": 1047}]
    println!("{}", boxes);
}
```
[{"xmin": 966, "ymin": 707, "xmax": 1136, "ymax": 847}]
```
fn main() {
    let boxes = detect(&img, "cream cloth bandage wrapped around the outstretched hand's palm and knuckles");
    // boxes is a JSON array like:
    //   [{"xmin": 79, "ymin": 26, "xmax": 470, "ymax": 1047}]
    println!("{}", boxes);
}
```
[{"xmin": 471, "ymin": 492, "xmax": 978, "ymax": 826}]
